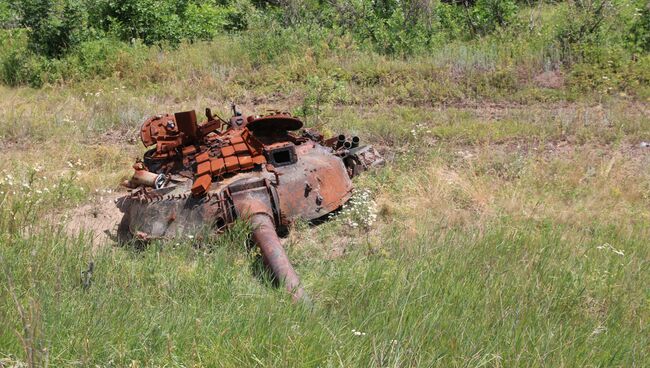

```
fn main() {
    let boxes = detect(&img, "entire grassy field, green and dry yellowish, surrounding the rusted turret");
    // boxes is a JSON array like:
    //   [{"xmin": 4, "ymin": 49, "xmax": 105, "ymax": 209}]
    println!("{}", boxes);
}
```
[{"xmin": 0, "ymin": 18, "xmax": 650, "ymax": 367}]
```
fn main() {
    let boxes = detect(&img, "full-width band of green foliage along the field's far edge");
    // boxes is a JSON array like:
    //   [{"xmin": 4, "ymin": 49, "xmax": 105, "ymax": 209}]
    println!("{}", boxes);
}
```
[{"xmin": 0, "ymin": 0, "xmax": 650, "ymax": 91}]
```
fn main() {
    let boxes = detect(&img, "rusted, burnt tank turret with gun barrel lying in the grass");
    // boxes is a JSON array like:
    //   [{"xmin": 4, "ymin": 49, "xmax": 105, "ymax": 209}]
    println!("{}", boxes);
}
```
[{"xmin": 117, "ymin": 105, "xmax": 383, "ymax": 300}]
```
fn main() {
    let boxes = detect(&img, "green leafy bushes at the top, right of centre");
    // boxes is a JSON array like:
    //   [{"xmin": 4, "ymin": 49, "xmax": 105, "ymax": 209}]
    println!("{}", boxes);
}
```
[{"xmin": 303, "ymin": 0, "xmax": 517, "ymax": 55}]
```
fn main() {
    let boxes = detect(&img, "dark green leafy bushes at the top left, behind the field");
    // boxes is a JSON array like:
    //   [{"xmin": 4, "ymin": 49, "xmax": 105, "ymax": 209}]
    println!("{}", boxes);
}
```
[{"xmin": 7, "ymin": 0, "xmax": 250, "ymax": 58}]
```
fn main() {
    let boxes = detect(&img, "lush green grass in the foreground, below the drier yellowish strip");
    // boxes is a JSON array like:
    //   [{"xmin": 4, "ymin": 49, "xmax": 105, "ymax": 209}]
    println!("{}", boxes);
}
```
[{"xmin": 0, "ymin": 183, "xmax": 650, "ymax": 366}]
